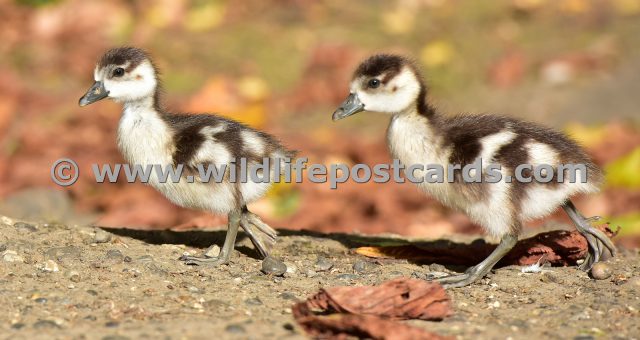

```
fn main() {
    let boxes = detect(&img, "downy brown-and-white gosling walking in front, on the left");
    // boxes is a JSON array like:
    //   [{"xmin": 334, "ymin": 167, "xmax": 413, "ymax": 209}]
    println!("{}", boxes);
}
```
[{"xmin": 79, "ymin": 47, "xmax": 293, "ymax": 265}]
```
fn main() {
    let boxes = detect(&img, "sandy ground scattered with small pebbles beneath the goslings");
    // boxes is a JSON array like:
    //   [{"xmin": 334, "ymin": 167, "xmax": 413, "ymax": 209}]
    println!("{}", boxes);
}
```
[{"xmin": 0, "ymin": 217, "xmax": 640, "ymax": 339}]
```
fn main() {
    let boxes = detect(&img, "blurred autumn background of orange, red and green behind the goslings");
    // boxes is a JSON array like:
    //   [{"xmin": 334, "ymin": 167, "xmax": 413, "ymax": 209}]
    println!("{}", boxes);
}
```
[{"xmin": 0, "ymin": 0, "xmax": 640, "ymax": 245}]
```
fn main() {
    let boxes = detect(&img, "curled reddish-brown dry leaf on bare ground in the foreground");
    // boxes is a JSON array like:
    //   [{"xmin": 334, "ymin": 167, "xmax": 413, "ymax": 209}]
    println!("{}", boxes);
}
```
[{"xmin": 292, "ymin": 278, "xmax": 453, "ymax": 339}]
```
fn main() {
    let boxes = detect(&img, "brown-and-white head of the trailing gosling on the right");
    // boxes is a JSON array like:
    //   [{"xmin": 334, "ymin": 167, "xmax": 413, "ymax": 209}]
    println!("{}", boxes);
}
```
[{"xmin": 333, "ymin": 54, "xmax": 426, "ymax": 120}]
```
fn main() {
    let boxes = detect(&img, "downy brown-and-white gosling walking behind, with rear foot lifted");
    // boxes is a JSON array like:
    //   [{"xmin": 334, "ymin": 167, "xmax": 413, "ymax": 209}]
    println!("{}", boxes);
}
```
[{"xmin": 333, "ymin": 54, "xmax": 616, "ymax": 287}]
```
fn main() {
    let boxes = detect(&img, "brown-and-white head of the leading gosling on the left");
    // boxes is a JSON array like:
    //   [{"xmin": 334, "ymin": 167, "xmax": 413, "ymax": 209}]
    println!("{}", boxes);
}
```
[{"xmin": 79, "ymin": 47, "xmax": 158, "ymax": 106}]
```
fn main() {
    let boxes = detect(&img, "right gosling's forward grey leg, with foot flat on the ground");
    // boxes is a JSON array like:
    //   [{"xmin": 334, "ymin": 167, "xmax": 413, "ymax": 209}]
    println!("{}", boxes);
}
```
[{"xmin": 433, "ymin": 234, "xmax": 518, "ymax": 288}]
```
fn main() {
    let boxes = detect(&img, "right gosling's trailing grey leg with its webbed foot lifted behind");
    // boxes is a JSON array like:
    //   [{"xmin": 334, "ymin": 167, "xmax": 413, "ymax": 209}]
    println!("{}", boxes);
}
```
[{"xmin": 562, "ymin": 201, "xmax": 616, "ymax": 271}]
